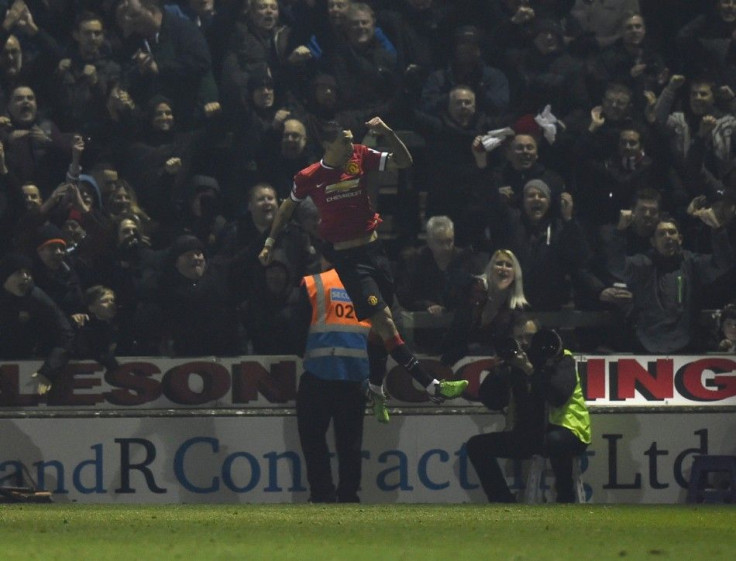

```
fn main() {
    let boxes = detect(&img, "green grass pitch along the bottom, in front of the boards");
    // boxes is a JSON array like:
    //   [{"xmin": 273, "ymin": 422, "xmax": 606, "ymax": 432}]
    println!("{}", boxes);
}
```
[{"xmin": 0, "ymin": 504, "xmax": 736, "ymax": 561}]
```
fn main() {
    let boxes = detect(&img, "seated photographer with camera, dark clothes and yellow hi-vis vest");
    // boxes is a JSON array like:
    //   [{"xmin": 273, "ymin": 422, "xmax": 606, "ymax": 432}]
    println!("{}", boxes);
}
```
[{"xmin": 466, "ymin": 317, "xmax": 591, "ymax": 503}]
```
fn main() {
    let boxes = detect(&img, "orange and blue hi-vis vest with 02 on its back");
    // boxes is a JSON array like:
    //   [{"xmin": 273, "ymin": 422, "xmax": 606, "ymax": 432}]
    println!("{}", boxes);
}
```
[{"xmin": 302, "ymin": 269, "xmax": 371, "ymax": 382}]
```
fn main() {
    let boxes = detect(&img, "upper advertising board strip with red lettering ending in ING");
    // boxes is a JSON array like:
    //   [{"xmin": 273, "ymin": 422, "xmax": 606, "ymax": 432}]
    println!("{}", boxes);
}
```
[{"xmin": 0, "ymin": 355, "xmax": 736, "ymax": 412}]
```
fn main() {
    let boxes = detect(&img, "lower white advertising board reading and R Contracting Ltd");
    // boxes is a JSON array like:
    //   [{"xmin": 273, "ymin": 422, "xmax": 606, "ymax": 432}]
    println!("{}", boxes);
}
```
[{"xmin": 0, "ymin": 413, "xmax": 736, "ymax": 503}]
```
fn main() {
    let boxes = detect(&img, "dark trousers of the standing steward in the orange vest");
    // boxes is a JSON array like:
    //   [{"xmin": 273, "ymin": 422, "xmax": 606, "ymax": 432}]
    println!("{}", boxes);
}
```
[{"xmin": 296, "ymin": 372, "xmax": 366, "ymax": 503}]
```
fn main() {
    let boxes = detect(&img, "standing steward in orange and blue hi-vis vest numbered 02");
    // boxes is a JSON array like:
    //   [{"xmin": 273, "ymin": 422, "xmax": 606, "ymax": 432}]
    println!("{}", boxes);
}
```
[{"xmin": 296, "ymin": 269, "xmax": 370, "ymax": 503}]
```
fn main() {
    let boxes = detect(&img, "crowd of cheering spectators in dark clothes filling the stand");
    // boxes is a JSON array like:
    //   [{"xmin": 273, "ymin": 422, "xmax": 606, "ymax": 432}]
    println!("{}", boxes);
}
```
[{"xmin": 0, "ymin": 0, "xmax": 736, "ymax": 374}]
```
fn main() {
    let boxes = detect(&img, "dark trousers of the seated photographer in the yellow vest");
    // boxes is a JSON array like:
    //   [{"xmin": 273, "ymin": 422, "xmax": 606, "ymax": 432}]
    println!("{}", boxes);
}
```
[{"xmin": 466, "ymin": 425, "xmax": 587, "ymax": 503}]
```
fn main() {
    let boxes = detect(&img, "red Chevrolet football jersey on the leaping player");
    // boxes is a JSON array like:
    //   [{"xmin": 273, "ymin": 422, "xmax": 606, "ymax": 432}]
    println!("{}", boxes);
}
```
[{"xmin": 291, "ymin": 144, "xmax": 388, "ymax": 243}]
